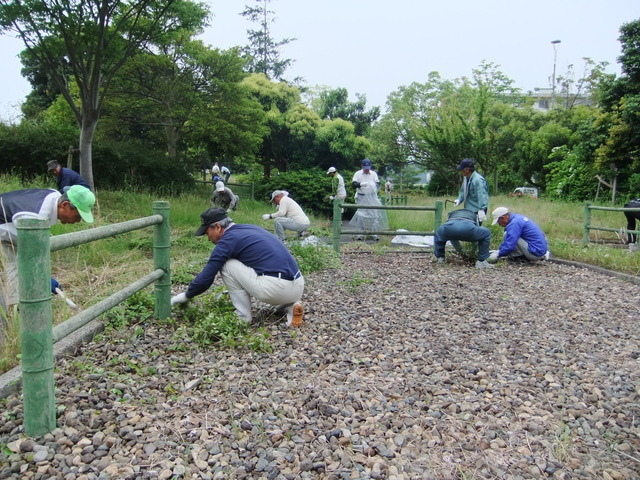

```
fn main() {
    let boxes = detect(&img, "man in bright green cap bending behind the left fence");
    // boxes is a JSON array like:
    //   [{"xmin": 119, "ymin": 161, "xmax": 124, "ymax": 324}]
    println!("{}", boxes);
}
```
[{"xmin": 0, "ymin": 185, "xmax": 96, "ymax": 310}]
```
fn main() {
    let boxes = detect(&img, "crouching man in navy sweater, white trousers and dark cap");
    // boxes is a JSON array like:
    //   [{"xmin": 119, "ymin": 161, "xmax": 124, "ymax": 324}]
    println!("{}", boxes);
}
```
[{"xmin": 171, "ymin": 208, "xmax": 304, "ymax": 327}]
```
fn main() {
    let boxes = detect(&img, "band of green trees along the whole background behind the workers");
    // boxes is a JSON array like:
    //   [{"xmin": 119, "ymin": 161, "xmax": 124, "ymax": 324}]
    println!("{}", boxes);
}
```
[{"xmin": 0, "ymin": 0, "xmax": 640, "ymax": 206}]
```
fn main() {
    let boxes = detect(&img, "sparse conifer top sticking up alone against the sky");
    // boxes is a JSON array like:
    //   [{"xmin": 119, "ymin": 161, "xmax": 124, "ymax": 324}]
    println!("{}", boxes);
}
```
[{"xmin": 240, "ymin": 0, "xmax": 296, "ymax": 80}]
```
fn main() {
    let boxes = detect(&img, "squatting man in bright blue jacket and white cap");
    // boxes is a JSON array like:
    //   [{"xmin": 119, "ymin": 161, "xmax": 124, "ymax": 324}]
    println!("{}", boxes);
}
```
[{"xmin": 489, "ymin": 207, "xmax": 551, "ymax": 262}]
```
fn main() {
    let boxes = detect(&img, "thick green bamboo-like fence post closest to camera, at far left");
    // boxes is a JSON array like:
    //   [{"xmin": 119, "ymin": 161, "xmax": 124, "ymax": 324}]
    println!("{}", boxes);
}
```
[{"xmin": 16, "ymin": 218, "xmax": 56, "ymax": 437}]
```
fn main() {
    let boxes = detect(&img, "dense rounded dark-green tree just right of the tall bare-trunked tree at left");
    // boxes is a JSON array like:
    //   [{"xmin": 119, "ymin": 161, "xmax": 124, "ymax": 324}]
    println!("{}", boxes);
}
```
[{"xmin": 102, "ymin": 35, "xmax": 264, "ymax": 167}]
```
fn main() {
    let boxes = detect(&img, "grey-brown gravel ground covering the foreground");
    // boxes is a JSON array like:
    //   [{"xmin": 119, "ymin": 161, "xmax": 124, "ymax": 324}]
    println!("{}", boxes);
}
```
[{"xmin": 0, "ymin": 252, "xmax": 640, "ymax": 480}]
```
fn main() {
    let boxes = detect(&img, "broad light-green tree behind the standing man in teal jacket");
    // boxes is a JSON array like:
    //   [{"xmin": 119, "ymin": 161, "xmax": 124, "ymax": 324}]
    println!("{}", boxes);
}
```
[{"xmin": 373, "ymin": 62, "xmax": 523, "ymax": 193}]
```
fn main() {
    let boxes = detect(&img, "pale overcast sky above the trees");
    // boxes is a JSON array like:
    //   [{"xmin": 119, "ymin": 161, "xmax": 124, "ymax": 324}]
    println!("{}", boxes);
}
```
[{"xmin": 0, "ymin": 0, "xmax": 640, "ymax": 120}]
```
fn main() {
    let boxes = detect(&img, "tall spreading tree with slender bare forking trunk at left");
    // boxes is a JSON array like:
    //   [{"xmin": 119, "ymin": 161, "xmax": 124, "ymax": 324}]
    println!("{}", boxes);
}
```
[{"xmin": 0, "ymin": 0, "xmax": 207, "ymax": 185}]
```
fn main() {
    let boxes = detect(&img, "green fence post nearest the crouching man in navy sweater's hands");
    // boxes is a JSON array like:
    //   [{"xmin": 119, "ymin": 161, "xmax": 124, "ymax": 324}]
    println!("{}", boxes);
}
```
[{"xmin": 153, "ymin": 201, "xmax": 171, "ymax": 319}]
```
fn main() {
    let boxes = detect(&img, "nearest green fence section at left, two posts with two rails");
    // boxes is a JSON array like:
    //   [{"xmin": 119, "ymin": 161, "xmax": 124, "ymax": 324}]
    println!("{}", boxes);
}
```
[{"xmin": 16, "ymin": 202, "xmax": 171, "ymax": 436}]
